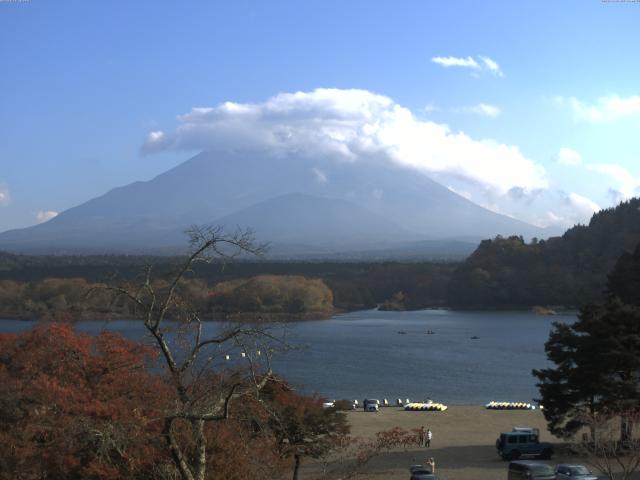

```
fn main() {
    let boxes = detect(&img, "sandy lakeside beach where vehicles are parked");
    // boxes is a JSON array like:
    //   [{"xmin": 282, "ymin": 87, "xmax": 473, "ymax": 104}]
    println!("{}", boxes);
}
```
[{"xmin": 303, "ymin": 406, "xmax": 604, "ymax": 480}]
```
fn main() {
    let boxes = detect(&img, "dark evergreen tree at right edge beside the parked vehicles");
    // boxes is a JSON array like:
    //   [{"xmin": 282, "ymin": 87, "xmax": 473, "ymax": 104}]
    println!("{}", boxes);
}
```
[{"xmin": 533, "ymin": 246, "xmax": 640, "ymax": 436}]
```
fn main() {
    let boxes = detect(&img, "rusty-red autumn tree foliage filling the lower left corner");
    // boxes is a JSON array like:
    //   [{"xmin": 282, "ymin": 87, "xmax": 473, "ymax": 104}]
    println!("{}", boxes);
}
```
[{"xmin": 0, "ymin": 324, "xmax": 168, "ymax": 479}]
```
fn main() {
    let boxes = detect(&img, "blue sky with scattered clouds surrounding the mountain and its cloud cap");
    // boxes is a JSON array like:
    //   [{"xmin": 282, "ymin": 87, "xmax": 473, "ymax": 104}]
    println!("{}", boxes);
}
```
[{"xmin": 0, "ymin": 0, "xmax": 640, "ymax": 231}]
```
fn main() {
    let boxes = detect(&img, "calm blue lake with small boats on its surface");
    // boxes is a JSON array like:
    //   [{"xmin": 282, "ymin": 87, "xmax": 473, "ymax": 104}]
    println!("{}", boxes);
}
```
[{"xmin": 0, "ymin": 310, "xmax": 575, "ymax": 405}]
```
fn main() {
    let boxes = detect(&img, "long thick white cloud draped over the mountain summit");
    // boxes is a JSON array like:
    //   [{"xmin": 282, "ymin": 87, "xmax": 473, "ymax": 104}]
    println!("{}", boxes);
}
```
[{"xmin": 142, "ymin": 89, "xmax": 549, "ymax": 195}]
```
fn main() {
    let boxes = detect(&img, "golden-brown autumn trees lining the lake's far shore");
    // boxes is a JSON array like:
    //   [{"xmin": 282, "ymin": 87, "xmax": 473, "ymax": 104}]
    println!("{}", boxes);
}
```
[{"xmin": 0, "ymin": 275, "xmax": 334, "ymax": 322}]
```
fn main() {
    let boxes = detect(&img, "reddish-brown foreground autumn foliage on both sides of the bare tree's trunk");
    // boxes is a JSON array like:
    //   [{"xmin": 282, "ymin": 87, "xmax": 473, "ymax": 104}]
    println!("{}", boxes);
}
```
[{"xmin": 0, "ymin": 324, "xmax": 322, "ymax": 480}]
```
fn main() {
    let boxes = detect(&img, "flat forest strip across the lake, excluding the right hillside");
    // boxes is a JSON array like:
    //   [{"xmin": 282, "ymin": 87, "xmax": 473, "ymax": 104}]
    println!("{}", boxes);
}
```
[{"xmin": 0, "ymin": 253, "xmax": 455, "ymax": 318}]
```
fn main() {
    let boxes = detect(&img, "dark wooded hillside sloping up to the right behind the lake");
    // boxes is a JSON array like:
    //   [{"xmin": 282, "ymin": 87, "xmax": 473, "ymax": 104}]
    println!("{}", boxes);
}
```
[{"xmin": 447, "ymin": 198, "xmax": 640, "ymax": 308}]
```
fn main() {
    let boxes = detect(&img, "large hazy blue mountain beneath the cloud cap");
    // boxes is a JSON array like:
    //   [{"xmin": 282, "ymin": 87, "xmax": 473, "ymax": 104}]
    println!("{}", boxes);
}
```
[{"xmin": 0, "ymin": 152, "xmax": 549, "ymax": 255}]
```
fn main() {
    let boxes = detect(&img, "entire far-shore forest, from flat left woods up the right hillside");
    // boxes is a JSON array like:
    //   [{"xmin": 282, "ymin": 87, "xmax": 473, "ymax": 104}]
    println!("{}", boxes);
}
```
[{"xmin": 0, "ymin": 199, "xmax": 640, "ymax": 319}]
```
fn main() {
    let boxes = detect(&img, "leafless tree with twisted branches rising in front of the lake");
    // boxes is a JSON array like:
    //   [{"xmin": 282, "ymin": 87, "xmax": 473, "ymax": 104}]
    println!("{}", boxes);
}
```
[{"xmin": 94, "ymin": 227, "xmax": 282, "ymax": 480}]
